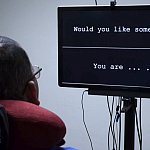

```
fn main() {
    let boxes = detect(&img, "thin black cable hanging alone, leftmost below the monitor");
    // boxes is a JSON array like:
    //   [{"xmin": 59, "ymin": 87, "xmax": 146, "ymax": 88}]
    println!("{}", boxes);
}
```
[{"xmin": 81, "ymin": 90, "xmax": 94, "ymax": 150}]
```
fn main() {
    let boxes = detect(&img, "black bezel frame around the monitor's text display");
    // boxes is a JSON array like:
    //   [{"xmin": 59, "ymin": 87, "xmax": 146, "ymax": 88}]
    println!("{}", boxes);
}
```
[{"xmin": 57, "ymin": 5, "xmax": 150, "ymax": 98}]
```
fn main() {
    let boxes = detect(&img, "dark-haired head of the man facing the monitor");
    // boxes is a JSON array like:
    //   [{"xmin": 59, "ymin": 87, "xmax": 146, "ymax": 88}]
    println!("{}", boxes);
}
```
[{"xmin": 0, "ymin": 36, "xmax": 39, "ymax": 104}]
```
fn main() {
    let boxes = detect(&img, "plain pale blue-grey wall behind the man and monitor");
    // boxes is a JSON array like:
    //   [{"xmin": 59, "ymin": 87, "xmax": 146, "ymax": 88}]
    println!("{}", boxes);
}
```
[{"xmin": 0, "ymin": 0, "xmax": 150, "ymax": 150}]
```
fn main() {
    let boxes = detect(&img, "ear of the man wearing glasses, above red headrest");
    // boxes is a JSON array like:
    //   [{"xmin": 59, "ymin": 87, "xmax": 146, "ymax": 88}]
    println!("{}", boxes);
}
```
[{"xmin": 24, "ymin": 81, "xmax": 40, "ymax": 105}]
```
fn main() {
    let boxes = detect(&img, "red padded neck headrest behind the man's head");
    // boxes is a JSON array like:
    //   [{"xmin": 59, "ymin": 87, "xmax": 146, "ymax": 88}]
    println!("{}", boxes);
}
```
[{"xmin": 0, "ymin": 100, "xmax": 66, "ymax": 150}]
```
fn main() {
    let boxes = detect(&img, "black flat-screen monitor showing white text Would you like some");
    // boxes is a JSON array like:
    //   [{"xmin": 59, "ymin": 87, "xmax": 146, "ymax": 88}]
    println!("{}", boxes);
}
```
[{"xmin": 58, "ymin": 5, "xmax": 150, "ymax": 97}]
